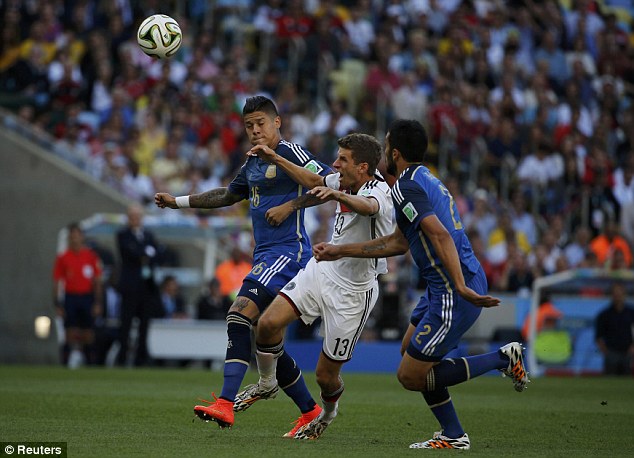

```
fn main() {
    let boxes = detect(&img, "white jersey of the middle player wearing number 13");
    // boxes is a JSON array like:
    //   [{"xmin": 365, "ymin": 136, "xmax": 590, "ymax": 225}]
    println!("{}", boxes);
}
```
[{"xmin": 319, "ymin": 173, "xmax": 394, "ymax": 291}]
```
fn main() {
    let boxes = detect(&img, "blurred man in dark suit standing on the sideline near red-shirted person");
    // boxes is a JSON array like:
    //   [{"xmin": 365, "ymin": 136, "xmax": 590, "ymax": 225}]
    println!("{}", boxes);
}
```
[{"xmin": 117, "ymin": 204, "xmax": 160, "ymax": 366}]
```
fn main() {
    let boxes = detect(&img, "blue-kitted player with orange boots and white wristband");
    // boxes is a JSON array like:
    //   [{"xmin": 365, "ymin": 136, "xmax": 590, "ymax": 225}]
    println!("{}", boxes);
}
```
[{"xmin": 154, "ymin": 96, "xmax": 331, "ymax": 437}]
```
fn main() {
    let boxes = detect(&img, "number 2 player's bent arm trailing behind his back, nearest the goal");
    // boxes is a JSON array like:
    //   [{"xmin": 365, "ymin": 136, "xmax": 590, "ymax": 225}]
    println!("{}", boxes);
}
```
[{"xmin": 420, "ymin": 215, "xmax": 500, "ymax": 307}]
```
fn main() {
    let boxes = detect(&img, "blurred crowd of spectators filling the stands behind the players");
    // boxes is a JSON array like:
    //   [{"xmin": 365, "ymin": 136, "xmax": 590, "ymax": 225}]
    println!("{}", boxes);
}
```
[{"xmin": 0, "ymin": 0, "xmax": 634, "ymax": 306}]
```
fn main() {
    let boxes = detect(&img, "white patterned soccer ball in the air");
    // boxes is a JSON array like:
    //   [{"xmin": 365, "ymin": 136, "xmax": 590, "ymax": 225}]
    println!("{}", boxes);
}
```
[{"xmin": 136, "ymin": 14, "xmax": 183, "ymax": 59}]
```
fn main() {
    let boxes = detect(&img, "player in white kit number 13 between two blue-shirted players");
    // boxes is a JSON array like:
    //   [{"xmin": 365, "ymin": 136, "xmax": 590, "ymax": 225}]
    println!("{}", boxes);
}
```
[{"xmin": 236, "ymin": 133, "xmax": 394, "ymax": 439}]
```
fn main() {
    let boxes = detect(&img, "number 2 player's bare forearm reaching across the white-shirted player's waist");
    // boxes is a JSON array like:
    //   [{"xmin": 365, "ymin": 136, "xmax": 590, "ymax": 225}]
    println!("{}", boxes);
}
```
[{"xmin": 313, "ymin": 228, "xmax": 409, "ymax": 261}]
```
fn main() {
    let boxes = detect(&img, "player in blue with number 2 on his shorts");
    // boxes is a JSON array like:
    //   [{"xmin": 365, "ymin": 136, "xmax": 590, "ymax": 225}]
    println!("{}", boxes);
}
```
[{"xmin": 313, "ymin": 120, "xmax": 528, "ymax": 449}]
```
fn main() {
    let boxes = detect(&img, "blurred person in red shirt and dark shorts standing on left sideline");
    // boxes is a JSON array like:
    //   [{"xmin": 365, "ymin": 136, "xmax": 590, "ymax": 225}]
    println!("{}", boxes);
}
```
[{"xmin": 53, "ymin": 223, "xmax": 102, "ymax": 368}]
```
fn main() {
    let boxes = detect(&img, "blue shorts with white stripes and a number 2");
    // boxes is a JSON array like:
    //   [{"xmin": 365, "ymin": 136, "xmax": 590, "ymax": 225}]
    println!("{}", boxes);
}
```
[{"xmin": 407, "ymin": 268, "xmax": 488, "ymax": 361}]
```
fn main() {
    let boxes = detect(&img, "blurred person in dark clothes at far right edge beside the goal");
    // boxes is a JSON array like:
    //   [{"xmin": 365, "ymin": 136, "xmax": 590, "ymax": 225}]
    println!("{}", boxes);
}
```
[{"xmin": 595, "ymin": 282, "xmax": 634, "ymax": 375}]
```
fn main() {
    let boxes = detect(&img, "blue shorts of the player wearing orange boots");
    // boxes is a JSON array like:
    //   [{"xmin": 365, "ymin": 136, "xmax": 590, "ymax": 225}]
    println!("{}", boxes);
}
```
[{"xmin": 238, "ymin": 254, "xmax": 305, "ymax": 313}]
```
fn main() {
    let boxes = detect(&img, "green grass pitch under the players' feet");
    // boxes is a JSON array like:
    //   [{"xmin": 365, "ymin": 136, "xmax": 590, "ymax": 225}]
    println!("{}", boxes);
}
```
[{"xmin": 0, "ymin": 366, "xmax": 634, "ymax": 458}]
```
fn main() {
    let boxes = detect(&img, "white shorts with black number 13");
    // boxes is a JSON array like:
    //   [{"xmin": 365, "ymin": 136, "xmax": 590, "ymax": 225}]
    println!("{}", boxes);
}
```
[{"xmin": 279, "ymin": 258, "xmax": 379, "ymax": 361}]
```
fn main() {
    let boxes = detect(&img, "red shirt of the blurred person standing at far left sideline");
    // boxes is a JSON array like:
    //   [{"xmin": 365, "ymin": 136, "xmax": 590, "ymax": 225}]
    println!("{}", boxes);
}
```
[{"xmin": 53, "ymin": 248, "xmax": 102, "ymax": 294}]
